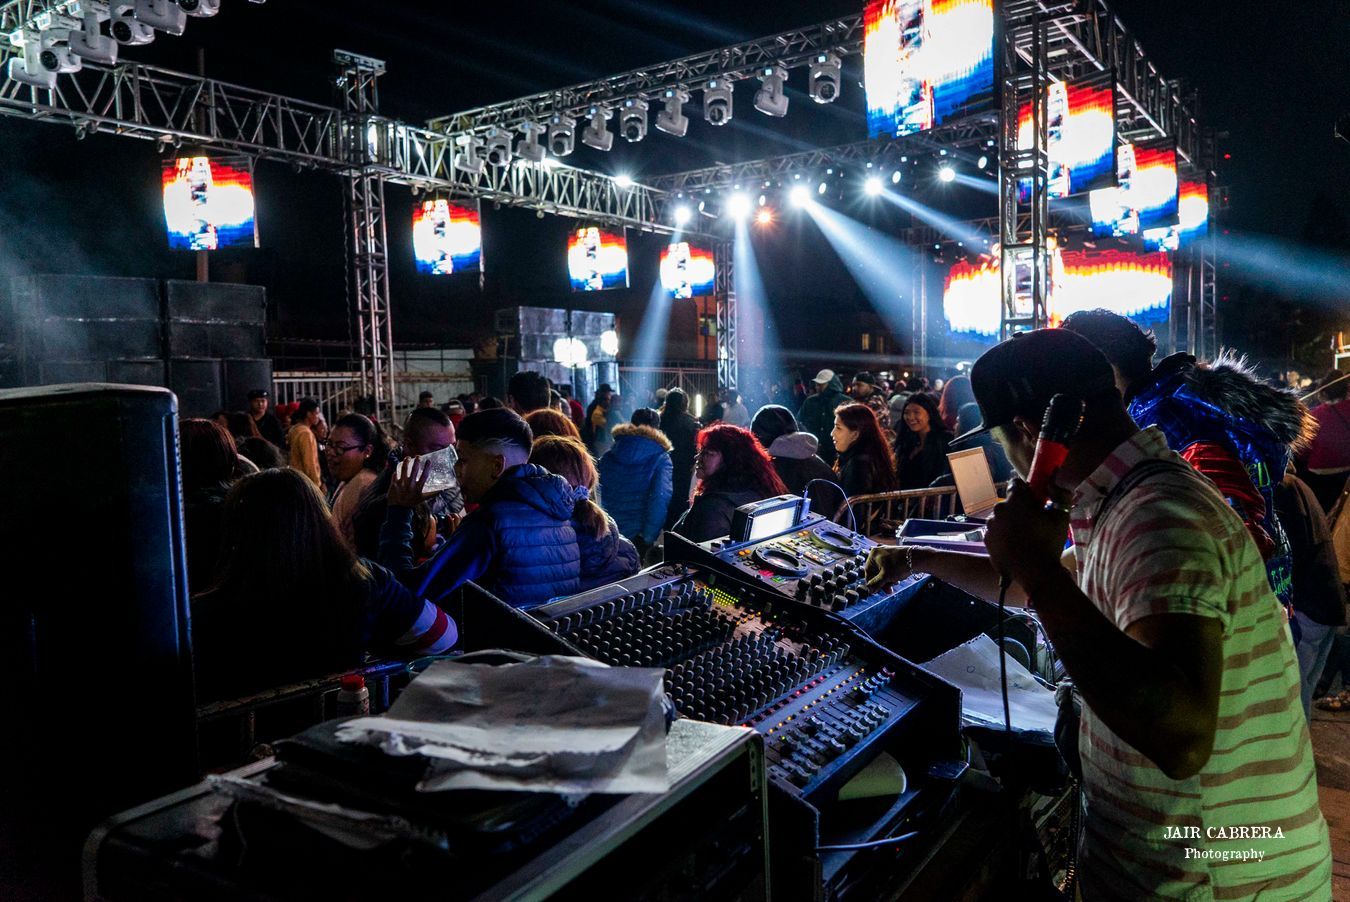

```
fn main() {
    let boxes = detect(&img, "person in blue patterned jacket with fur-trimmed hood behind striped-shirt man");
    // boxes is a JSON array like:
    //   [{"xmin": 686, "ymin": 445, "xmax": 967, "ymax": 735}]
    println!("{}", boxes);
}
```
[{"xmin": 1064, "ymin": 309, "xmax": 1316, "ymax": 609}]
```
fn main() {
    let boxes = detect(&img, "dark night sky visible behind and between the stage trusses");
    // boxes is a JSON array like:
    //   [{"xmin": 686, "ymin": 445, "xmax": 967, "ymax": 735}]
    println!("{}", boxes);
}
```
[{"xmin": 0, "ymin": 0, "xmax": 1350, "ymax": 372}]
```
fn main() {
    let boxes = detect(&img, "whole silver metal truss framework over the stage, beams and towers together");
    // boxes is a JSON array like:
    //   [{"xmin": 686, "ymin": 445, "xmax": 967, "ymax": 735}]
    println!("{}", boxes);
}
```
[{"xmin": 0, "ymin": 0, "xmax": 1218, "ymax": 419}]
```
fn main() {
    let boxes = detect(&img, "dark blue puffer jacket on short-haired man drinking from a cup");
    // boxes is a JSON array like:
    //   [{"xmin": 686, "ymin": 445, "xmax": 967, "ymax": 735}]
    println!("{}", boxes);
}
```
[{"xmin": 379, "ymin": 463, "xmax": 582, "ymax": 609}]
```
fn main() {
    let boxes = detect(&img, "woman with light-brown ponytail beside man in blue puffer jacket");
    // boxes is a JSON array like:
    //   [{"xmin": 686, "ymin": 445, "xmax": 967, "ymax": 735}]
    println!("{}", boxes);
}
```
[{"xmin": 529, "ymin": 437, "xmax": 639, "ymax": 591}]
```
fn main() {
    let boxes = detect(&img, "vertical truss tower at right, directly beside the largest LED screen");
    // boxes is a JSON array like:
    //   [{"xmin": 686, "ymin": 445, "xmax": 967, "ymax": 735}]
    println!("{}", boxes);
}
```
[{"xmin": 999, "ymin": 15, "xmax": 1050, "ymax": 339}]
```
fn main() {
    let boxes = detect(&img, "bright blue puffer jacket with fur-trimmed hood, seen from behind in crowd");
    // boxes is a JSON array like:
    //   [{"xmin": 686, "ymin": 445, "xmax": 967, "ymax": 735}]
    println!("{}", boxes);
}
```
[{"xmin": 599, "ymin": 424, "xmax": 672, "ymax": 544}]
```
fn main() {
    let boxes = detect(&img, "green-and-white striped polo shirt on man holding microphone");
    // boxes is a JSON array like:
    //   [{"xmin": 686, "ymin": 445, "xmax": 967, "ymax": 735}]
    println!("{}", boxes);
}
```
[{"xmin": 1071, "ymin": 428, "xmax": 1331, "ymax": 899}]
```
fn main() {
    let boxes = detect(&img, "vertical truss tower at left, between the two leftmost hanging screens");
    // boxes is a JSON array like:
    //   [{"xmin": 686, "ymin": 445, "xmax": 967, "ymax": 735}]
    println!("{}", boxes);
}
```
[{"xmin": 333, "ymin": 50, "xmax": 397, "ymax": 427}]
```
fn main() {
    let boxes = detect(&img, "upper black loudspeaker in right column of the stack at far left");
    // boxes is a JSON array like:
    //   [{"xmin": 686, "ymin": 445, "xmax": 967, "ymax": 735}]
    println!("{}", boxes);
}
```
[{"xmin": 165, "ymin": 280, "xmax": 267, "ymax": 358}]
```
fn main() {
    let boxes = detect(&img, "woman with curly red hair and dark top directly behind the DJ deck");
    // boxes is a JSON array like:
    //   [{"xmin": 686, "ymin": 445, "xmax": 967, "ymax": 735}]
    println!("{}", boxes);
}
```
[{"xmin": 675, "ymin": 424, "xmax": 787, "ymax": 541}]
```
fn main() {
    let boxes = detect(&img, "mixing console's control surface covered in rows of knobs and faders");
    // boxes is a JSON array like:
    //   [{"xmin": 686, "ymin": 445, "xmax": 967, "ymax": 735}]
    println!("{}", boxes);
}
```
[{"xmin": 531, "ymin": 566, "xmax": 959, "ymax": 794}]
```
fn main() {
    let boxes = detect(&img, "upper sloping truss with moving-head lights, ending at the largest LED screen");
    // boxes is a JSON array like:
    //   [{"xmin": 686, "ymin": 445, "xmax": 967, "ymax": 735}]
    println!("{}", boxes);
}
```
[{"xmin": 428, "ymin": 16, "xmax": 863, "ymax": 134}]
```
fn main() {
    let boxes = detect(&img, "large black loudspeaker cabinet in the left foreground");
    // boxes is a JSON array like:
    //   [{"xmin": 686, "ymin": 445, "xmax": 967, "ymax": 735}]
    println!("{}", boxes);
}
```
[{"xmin": 0, "ymin": 385, "xmax": 197, "ymax": 898}]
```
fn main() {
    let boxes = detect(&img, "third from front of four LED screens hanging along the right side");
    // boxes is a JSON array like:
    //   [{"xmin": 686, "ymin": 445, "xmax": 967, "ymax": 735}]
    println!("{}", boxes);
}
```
[{"xmin": 1088, "ymin": 140, "xmax": 1177, "ymax": 238}]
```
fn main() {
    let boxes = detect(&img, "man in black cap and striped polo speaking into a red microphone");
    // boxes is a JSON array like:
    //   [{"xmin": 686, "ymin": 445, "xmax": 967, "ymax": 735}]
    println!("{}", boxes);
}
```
[{"xmin": 869, "ymin": 329, "xmax": 1331, "ymax": 899}]
